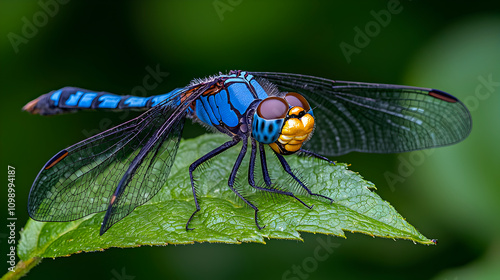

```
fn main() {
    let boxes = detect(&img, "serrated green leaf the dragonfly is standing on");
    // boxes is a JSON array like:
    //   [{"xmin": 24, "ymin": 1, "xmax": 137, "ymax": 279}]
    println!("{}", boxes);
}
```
[{"xmin": 18, "ymin": 134, "xmax": 432, "ymax": 260}]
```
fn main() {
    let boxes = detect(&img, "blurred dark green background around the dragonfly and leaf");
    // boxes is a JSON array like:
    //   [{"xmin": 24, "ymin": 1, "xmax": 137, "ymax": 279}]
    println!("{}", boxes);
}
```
[{"xmin": 0, "ymin": 0, "xmax": 500, "ymax": 280}]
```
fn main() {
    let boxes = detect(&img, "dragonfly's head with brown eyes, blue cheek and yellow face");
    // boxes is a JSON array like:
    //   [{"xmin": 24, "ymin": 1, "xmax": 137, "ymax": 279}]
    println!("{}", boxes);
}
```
[{"xmin": 252, "ymin": 92, "xmax": 314, "ymax": 155}]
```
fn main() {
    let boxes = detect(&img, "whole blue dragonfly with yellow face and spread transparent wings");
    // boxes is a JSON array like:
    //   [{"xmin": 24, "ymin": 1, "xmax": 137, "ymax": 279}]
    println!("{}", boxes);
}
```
[{"xmin": 23, "ymin": 70, "xmax": 472, "ymax": 235}]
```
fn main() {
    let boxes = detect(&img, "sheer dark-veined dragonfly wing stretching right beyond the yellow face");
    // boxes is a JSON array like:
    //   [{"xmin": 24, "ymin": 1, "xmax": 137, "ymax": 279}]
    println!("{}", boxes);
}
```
[{"xmin": 250, "ymin": 72, "xmax": 472, "ymax": 156}]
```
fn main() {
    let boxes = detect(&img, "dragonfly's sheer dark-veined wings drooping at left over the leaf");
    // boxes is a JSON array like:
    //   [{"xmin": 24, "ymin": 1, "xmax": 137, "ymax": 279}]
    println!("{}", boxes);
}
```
[{"xmin": 28, "ymin": 85, "xmax": 207, "ymax": 233}]
